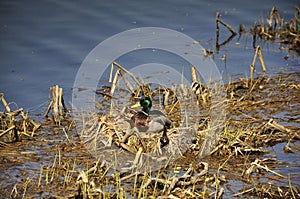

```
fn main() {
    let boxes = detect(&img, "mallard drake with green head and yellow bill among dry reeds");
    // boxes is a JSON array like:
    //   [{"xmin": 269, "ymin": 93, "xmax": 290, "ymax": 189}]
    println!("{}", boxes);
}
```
[{"xmin": 122, "ymin": 97, "xmax": 172, "ymax": 145}]
